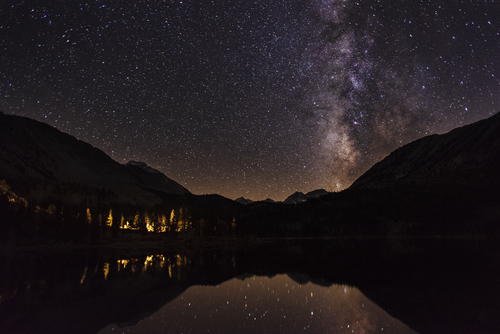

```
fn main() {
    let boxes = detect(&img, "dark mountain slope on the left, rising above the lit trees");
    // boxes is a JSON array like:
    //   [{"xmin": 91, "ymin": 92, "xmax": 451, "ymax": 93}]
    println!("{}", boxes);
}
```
[{"xmin": 0, "ymin": 113, "xmax": 189, "ymax": 205}]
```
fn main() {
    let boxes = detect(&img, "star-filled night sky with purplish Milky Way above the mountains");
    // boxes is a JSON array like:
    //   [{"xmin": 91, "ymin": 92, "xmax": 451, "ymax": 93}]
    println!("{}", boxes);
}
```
[{"xmin": 0, "ymin": 0, "xmax": 500, "ymax": 200}]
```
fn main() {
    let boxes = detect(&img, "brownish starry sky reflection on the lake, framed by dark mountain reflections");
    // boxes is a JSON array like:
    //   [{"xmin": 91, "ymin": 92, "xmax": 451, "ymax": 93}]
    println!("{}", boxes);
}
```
[{"xmin": 99, "ymin": 274, "xmax": 415, "ymax": 334}]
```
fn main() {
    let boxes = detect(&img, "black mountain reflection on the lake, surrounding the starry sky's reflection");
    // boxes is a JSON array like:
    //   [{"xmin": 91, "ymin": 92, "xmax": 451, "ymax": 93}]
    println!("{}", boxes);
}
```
[{"xmin": 0, "ymin": 240, "xmax": 500, "ymax": 334}]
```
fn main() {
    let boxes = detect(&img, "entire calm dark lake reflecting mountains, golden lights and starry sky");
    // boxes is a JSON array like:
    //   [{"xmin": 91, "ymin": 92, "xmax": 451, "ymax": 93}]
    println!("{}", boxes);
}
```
[{"xmin": 0, "ymin": 240, "xmax": 500, "ymax": 333}]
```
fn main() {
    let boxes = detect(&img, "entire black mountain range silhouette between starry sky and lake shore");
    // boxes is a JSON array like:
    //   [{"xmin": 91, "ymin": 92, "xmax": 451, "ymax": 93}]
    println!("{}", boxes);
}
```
[{"xmin": 0, "ymin": 114, "xmax": 500, "ymax": 237}]
